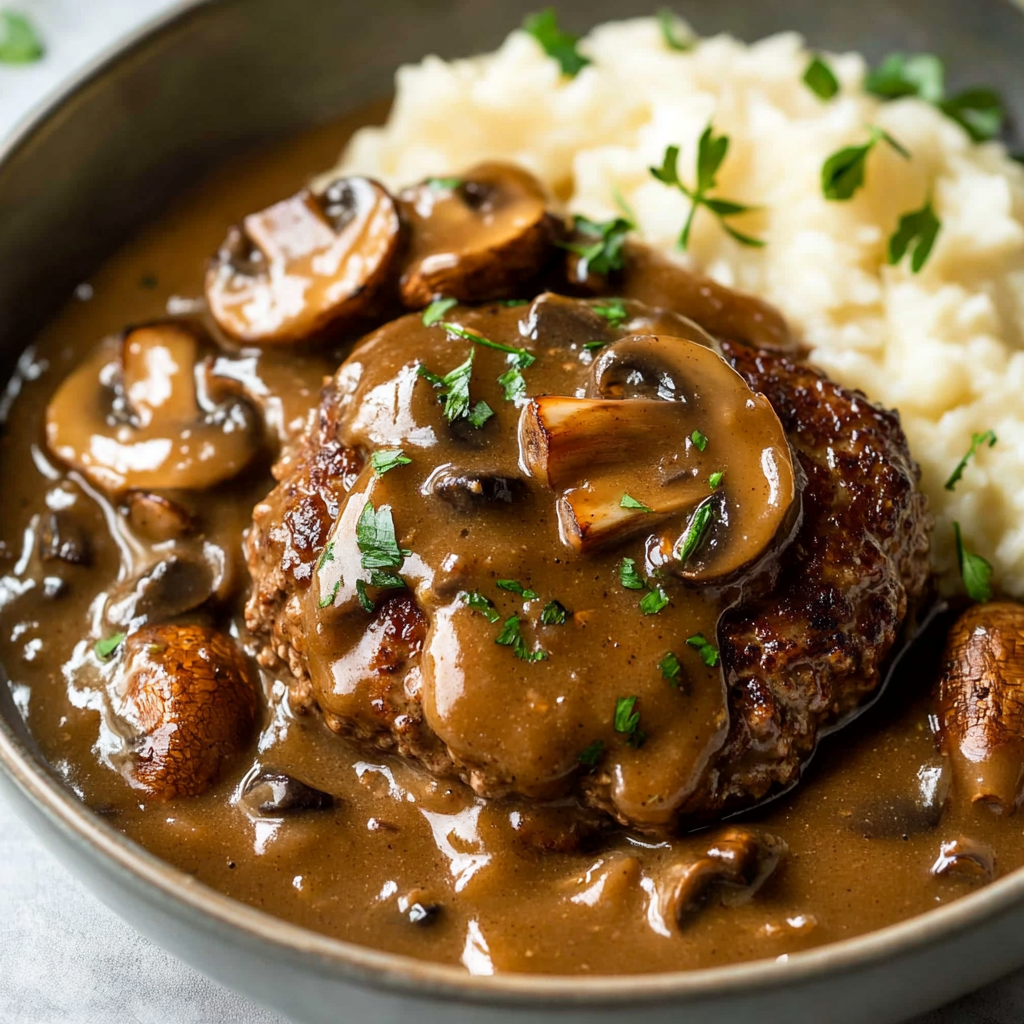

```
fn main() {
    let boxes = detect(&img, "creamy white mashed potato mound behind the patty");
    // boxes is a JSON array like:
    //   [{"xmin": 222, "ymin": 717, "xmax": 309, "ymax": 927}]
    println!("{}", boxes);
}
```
[{"xmin": 331, "ymin": 18, "xmax": 1024, "ymax": 596}]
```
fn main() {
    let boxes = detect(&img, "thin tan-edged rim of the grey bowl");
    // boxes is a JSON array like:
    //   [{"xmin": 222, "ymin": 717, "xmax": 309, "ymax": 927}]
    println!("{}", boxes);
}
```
[{"xmin": 0, "ymin": 0, "xmax": 1024, "ymax": 1009}]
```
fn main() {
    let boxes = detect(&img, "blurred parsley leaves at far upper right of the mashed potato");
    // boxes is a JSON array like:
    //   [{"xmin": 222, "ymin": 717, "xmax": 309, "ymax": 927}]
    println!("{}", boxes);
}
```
[{"xmin": 864, "ymin": 53, "xmax": 1006, "ymax": 142}]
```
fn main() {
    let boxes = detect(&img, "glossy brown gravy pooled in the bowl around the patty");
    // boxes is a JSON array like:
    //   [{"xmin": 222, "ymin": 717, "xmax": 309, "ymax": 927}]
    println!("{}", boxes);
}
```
[{"xmin": 0, "ymin": 110, "xmax": 1024, "ymax": 974}]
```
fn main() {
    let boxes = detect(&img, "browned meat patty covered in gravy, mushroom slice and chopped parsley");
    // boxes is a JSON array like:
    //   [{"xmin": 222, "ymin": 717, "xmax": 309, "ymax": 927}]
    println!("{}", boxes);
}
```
[{"xmin": 247, "ymin": 295, "xmax": 930, "ymax": 828}]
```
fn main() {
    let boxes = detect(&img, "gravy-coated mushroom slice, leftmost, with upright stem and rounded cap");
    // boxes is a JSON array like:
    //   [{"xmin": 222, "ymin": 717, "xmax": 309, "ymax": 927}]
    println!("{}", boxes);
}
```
[{"xmin": 46, "ymin": 323, "xmax": 260, "ymax": 494}]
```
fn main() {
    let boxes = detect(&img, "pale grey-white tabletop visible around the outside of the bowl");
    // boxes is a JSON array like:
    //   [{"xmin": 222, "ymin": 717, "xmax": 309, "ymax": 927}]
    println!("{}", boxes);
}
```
[{"xmin": 0, "ymin": 0, "xmax": 1024, "ymax": 1024}]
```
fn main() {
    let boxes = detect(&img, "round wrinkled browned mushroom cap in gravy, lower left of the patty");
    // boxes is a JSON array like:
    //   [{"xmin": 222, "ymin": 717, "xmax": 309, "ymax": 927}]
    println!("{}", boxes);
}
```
[{"xmin": 109, "ymin": 626, "xmax": 256, "ymax": 800}]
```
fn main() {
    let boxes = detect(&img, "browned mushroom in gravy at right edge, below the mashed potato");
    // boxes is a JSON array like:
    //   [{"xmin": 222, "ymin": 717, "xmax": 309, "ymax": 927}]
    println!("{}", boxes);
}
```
[{"xmin": 938, "ymin": 602, "xmax": 1024, "ymax": 814}]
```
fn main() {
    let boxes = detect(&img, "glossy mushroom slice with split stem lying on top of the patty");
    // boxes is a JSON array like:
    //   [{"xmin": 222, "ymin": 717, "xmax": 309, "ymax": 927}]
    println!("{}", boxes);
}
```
[{"xmin": 519, "ymin": 336, "xmax": 797, "ymax": 580}]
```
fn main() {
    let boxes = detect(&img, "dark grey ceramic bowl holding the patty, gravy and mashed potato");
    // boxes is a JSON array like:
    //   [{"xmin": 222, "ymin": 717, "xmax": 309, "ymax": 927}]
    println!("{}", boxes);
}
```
[{"xmin": 0, "ymin": 0, "xmax": 1024, "ymax": 1024}]
